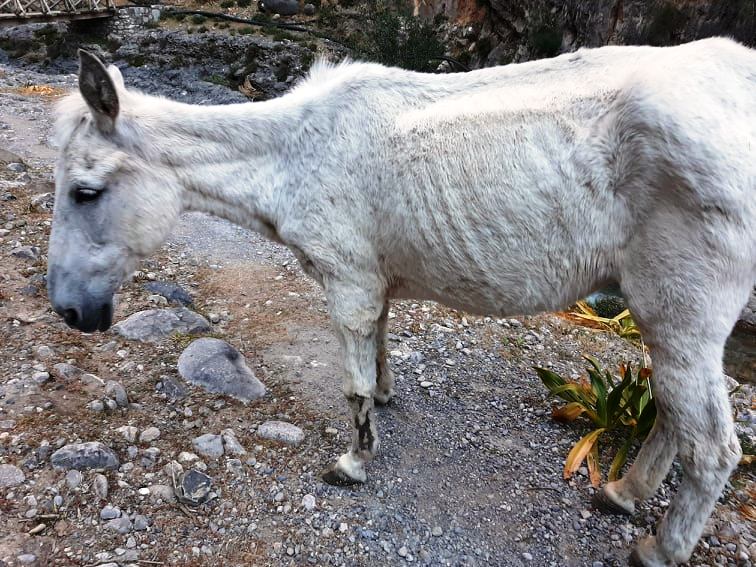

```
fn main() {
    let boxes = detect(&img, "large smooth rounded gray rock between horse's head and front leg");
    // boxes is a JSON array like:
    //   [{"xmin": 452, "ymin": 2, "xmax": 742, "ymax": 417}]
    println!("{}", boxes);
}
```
[{"xmin": 178, "ymin": 338, "xmax": 265, "ymax": 403}]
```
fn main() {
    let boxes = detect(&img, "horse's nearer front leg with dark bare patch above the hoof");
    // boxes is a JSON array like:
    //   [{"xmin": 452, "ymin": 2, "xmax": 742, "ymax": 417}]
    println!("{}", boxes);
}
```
[{"xmin": 323, "ymin": 282, "xmax": 384, "ymax": 485}]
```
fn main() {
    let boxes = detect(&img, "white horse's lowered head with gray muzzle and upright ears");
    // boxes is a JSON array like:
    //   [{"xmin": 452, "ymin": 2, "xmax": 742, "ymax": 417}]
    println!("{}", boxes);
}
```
[{"xmin": 47, "ymin": 51, "xmax": 181, "ymax": 332}]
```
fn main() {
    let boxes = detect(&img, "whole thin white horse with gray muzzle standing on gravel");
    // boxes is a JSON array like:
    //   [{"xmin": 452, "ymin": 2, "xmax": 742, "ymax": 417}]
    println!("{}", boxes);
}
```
[{"xmin": 48, "ymin": 39, "xmax": 756, "ymax": 566}]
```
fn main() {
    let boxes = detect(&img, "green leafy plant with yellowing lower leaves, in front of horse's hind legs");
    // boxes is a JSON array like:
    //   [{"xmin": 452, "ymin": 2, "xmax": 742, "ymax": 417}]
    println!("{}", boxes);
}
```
[{"xmin": 535, "ymin": 357, "xmax": 656, "ymax": 486}]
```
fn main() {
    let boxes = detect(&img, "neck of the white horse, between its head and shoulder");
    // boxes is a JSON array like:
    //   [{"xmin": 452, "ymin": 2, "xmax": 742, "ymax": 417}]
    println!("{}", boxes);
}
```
[{"xmin": 133, "ymin": 94, "xmax": 316, "ymax": 238}]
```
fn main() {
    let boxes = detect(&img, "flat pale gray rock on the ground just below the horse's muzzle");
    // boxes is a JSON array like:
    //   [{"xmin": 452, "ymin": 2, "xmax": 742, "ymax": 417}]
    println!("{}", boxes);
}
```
[{"xmin": 113, "ymin": 307, "xmax": 210, "ymax": 343}]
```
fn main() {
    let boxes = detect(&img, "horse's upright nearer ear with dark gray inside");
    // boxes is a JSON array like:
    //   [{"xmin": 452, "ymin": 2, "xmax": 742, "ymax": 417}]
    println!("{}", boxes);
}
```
[{"xmin": 79, "ymin": 49, "xmax": 118, "ymax": 133}]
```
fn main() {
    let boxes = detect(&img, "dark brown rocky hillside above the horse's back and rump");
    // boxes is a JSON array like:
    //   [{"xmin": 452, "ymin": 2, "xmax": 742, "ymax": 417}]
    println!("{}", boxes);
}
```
[{"xmin": 414, "ymin": 0, "xmax": 756, "ymax": 66}]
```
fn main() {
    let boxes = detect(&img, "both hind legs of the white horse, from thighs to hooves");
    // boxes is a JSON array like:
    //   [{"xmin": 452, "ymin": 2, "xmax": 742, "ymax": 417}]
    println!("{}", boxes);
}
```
[{"xmin": 602, "ymin": 223, "xmax": 753, "ymax": 567}]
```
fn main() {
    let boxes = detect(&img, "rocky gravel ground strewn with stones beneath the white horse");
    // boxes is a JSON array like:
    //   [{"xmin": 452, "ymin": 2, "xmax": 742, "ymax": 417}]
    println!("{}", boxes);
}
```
[{"xmin": 0, "ymin": 25, "xmax": 756, "ymax": 567}]
